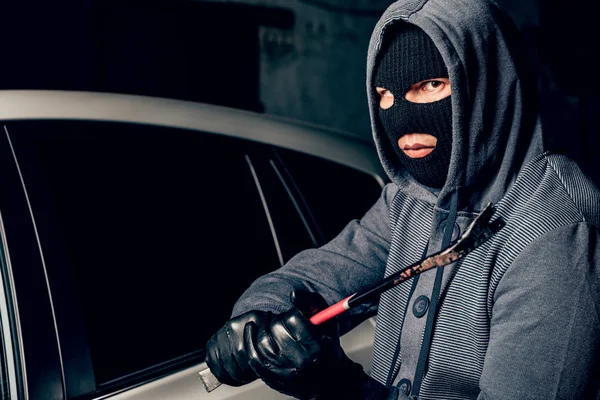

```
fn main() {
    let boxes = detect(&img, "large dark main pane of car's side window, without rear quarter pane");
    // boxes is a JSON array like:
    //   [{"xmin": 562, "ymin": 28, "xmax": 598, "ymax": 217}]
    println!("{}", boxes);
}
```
[{"xmin": 9, "ymin": 121, "xmax": 280, "ymax": 396}]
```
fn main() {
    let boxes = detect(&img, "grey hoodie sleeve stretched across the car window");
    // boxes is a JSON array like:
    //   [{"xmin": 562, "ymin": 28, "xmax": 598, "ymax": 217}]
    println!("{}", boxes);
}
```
[{"xmin": 232, "ymin": 183, "xmax": 398, "ymax": 330}]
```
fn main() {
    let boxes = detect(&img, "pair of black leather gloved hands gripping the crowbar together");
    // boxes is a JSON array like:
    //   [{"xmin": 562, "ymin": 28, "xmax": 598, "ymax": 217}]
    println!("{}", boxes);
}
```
[{"xmin": 206, "ymin": 291, "xmax": 398, "ymax": 400}]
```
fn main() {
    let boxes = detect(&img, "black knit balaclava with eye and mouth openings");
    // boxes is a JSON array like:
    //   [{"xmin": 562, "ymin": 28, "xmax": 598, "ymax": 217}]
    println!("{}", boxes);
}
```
[{"xmin": 375, "ymin": 23, "xmax": 452, "ymax": 189}]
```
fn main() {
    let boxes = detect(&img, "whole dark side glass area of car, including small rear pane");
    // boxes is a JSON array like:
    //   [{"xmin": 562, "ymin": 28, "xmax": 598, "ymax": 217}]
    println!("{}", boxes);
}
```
[{"xmin": 8, "ymin": 121, "xmax": 381, "ymax": 398}]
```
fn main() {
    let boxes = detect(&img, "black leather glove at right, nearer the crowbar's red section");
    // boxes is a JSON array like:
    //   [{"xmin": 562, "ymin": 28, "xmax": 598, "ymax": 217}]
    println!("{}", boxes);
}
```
[{"xmin": 244, "ymin": 291, "xmax": 397, "ymax": 399}]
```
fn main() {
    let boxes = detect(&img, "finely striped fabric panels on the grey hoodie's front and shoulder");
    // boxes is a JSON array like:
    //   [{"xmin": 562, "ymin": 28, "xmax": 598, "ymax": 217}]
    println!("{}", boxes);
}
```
[{"xmin": 371, "ymin": 154, "xmax": 598, "ymax": 400}]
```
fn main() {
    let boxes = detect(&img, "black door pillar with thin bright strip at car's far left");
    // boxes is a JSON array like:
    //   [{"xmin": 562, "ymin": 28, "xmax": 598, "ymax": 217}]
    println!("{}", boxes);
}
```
[{"xmin": 0, "ymin": 123, "xmax": 65, "ymax": 400}]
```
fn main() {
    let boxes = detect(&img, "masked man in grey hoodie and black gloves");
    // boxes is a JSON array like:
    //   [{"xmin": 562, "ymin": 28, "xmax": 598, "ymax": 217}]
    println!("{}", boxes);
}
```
[{"xmin": 206, "ymin": 0, "xmax": 600, "ymax": 400}]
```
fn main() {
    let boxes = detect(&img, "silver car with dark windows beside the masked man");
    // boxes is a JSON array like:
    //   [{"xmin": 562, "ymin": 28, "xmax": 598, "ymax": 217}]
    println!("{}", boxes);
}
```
[{"xmin": 0, "ymin": 90, "xmax": 387, "ymax": 400}]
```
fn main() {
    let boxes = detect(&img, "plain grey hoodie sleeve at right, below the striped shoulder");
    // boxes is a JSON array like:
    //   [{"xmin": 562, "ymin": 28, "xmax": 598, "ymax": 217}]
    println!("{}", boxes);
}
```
[{"xmin": 479, "ymin": 223, "xmax": 600, "ymax": 400}]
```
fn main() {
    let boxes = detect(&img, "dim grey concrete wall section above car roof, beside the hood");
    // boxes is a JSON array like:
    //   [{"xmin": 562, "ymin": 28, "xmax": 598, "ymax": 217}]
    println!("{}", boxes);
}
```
[{"xmin": 198, "ymin": 0, "xmax": 538, "ymax": 138}]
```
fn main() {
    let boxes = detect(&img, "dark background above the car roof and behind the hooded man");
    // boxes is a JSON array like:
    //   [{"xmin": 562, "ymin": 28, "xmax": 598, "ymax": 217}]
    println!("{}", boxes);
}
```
[{"xmin": 0, "ymin": 0, "xmax": 600, "ymax": 182}]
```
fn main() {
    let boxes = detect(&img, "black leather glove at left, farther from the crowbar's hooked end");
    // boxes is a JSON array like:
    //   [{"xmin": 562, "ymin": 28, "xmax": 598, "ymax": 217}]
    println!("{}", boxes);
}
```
[{"xmin": 206, "ymin": 311, "xmax": 274, "ymax": 386}]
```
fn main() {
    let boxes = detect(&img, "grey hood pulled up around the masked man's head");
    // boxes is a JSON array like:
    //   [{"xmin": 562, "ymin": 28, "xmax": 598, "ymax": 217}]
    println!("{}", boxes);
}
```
[{"xmin": 367, "ymin": 0, "xmax": 544, "ymax": 212}]
